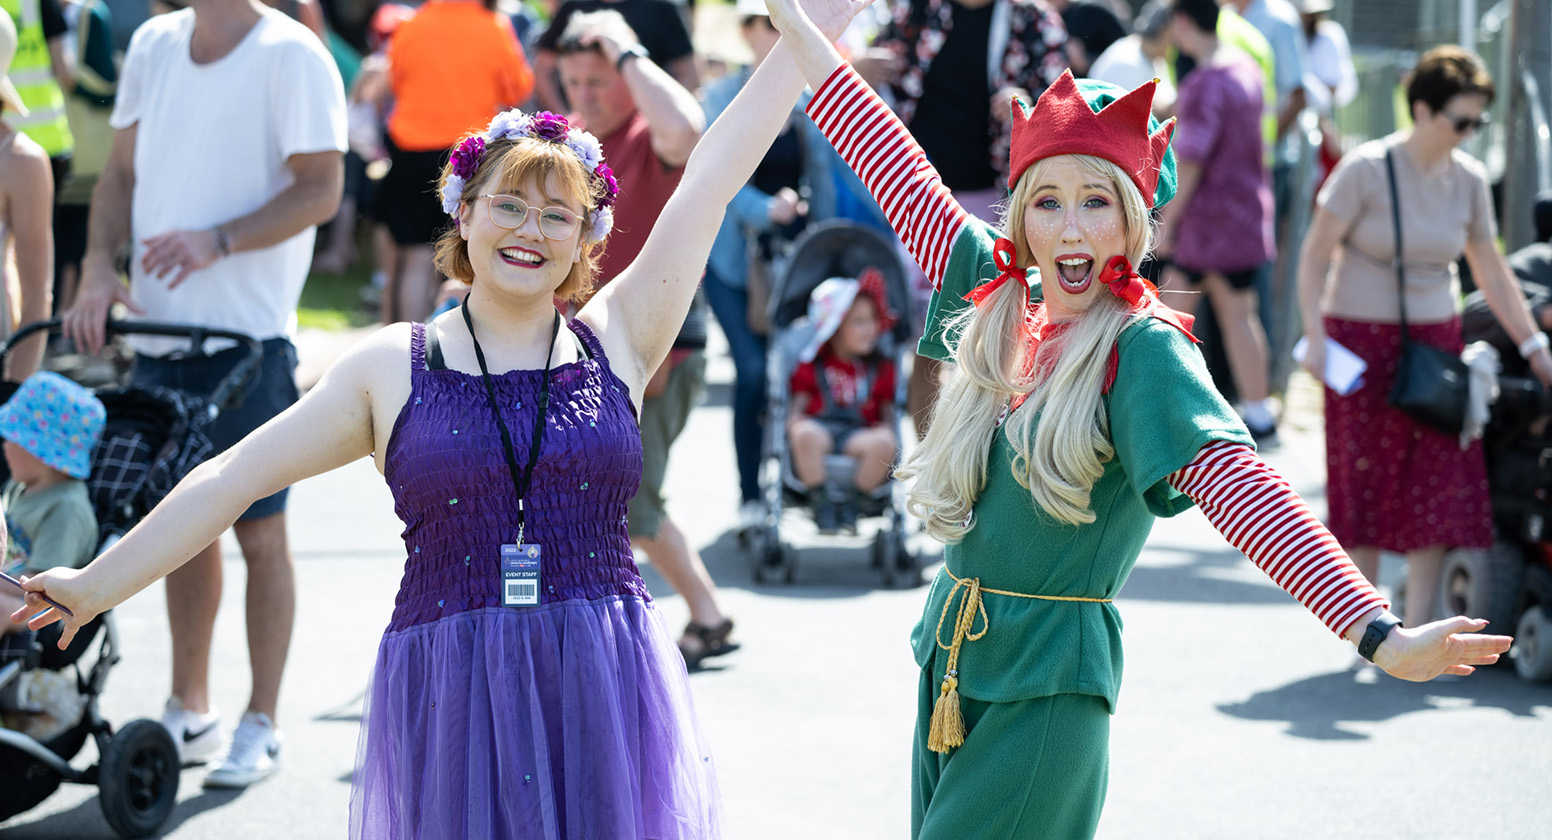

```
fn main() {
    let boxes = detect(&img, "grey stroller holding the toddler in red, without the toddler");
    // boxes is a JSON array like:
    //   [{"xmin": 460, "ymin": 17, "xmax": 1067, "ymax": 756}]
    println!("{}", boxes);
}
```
[{"xmin": 747, "ymin": 219, "xmax": 922, "ymax": 587}]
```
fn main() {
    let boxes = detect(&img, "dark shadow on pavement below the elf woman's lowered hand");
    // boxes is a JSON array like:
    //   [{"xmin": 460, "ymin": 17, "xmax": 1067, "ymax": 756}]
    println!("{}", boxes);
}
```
[{"xmin": 1218, "ymin": 665, "xmax": 1552, "ymax": 741}]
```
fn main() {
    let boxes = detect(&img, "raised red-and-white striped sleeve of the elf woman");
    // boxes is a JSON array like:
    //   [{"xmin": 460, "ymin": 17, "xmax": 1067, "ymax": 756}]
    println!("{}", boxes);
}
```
[{"xmin": 807, "ymin": 64, "xmax": 968, "ymax": 289}]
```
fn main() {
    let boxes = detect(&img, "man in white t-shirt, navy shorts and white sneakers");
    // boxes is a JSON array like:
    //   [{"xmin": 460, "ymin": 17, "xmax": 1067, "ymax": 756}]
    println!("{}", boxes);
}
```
[{"xmin": 64, "ymin": 0, "xmax": 345, "ymax": 787}]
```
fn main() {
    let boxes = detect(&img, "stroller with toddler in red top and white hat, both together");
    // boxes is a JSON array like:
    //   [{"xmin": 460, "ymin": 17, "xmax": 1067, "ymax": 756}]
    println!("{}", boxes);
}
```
[{"xmin": 750, "ymin": 219, "xmax": 922, "ymax": 585}]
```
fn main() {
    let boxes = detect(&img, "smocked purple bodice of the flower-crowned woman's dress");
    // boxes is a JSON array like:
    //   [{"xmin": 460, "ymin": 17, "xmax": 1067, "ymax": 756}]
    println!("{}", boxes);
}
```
[{"xmin": 383, "ymin": 320, "xmax": 650, "ymax": 632}]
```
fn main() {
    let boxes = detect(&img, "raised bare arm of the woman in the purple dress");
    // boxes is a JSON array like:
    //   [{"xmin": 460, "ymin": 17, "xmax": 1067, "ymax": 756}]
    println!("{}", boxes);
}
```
[{"xmin": 580, "ymin": 0, "xmax": 868, "ymax": 399}]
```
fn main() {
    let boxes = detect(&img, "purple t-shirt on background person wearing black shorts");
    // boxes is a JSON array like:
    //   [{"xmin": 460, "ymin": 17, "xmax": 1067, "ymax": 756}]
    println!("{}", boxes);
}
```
[{"xmin": 1173, "ymin": 54, "xmax": 1277, "ymax": 272}]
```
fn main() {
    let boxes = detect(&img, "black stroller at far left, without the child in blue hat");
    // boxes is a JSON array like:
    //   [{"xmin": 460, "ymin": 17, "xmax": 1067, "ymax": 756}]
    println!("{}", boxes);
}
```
[{"xmin": 0, "ymin": 321, "xmax": 262, "ymax": 837}]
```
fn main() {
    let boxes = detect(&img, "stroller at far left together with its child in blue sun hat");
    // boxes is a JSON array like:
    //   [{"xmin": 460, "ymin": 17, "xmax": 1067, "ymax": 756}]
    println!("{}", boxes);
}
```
[{"xmin": 0, "ymin": 321, "xmax": 262, "ymax": 837}]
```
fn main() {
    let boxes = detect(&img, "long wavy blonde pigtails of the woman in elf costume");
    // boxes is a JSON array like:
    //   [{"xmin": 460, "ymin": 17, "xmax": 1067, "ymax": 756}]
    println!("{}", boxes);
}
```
[{"xmin": 897, "ymin": 155, "xmax": 1150, "ymax": 542}]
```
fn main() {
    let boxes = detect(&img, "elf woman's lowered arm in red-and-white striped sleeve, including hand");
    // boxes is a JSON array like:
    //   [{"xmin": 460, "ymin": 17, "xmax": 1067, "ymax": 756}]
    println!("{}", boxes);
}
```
[{"xmin": 1169, "ymin": 441, "xmax": 1510, "ymax": 682}]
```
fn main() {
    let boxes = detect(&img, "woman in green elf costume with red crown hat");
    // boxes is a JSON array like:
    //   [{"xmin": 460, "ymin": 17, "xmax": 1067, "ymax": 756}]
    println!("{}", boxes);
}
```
[{"xmin": 770, "ymin": 0, "xmax": 1510, "ymax": 840}]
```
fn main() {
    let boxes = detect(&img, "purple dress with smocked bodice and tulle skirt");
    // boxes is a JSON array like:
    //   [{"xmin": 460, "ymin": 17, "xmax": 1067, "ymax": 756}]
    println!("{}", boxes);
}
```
[{"xmin": 351, "ymin": 321, "xmax": 720, "ymax": 840}]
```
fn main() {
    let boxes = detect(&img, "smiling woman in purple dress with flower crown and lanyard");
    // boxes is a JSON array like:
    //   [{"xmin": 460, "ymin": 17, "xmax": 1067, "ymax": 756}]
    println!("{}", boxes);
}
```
[{"xmin": 14, "ymin": 0, "xmax": 866, "ymax": 838}]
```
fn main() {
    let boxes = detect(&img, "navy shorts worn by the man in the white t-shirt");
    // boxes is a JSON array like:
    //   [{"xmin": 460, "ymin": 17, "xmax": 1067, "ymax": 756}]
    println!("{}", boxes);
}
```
[{"xmin": 129, "ymin": 338, "xmax": 300, "ymax": 520}]
